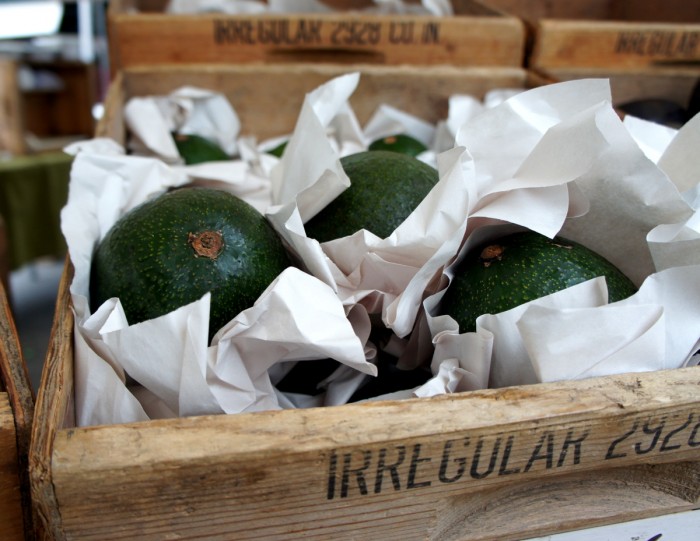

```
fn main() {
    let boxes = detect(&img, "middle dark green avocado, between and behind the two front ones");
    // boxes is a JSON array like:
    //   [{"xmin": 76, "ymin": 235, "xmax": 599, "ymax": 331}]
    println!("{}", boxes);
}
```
[{"xmin": 304, "ymin": 150, "xmax": 438, "ymax": 242}]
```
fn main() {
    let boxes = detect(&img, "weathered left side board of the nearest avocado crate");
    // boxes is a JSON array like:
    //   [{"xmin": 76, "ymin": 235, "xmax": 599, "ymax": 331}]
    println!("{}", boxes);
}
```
[{"xmin": 29, "ymin": 256, "xmax": 73, "ymax": 539}]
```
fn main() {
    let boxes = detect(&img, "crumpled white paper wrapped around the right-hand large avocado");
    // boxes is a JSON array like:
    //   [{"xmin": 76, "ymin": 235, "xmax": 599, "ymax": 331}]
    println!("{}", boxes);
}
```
[{"xmin": 416, "ymin": 86, "xmax": 700, "ymax": 396}]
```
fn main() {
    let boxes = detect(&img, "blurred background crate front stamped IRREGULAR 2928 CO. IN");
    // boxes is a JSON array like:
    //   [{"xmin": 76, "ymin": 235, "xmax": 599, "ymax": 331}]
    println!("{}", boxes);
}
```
[{"xmin": 107, "ymin": 0, "xmax": 525, "ymax": 71}]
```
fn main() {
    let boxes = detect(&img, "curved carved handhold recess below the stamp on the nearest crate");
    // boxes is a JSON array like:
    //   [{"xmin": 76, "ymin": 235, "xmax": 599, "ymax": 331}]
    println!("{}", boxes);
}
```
[{"xmin": 438, "ymin": 462, "xmax": 700, "ymax": 541}]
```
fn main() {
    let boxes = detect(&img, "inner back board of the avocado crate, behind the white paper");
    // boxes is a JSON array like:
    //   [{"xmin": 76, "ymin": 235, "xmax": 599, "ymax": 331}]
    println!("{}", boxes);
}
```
[{"xmin": 96, "ymin": 64, "xmax": 528, "ymax": 143}]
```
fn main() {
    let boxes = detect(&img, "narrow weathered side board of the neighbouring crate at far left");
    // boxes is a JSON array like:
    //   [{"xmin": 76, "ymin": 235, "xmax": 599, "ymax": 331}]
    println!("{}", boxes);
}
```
[{"xmin": 0, "ymin": 283, "xmax": 35, "ymax": 535}]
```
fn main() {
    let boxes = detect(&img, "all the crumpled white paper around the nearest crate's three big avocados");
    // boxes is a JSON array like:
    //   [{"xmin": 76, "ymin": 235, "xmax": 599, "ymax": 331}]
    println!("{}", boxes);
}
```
[{"xmin": 64, "ymin": 73, "xmax": 700, "ymax": 424}]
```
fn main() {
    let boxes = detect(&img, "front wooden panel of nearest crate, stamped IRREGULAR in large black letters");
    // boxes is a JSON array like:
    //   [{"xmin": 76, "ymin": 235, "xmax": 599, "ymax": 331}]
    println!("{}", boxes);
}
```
[{"xmin": 53, "ymin": 368, "xmax": 700, "ymax": 539}]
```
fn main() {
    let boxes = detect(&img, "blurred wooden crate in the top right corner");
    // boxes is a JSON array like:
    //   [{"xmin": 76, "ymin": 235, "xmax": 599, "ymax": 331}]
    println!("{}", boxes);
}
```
[{"xmin": 488, "ymin": 0, "xmax": 700, "ymax": 69}]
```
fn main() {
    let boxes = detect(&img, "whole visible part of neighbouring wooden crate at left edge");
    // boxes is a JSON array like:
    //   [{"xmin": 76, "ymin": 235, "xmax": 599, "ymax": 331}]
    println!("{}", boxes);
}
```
[{"xmin": 0, "ymin": 283, "xmax": 34, "ymax": 541}]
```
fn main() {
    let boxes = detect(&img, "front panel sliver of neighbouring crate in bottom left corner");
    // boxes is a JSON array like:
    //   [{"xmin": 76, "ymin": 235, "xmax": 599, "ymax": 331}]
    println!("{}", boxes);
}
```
[{"xmin": 0, "ymin": 392, "xmax": 24, "ymax": 541}]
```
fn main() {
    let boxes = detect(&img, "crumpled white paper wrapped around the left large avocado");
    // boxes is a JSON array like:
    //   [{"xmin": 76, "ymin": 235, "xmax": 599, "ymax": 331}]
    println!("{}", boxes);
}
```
[{"xmin": 62, "ymin": 134, "xmax": 376, "ymax": 426}]
